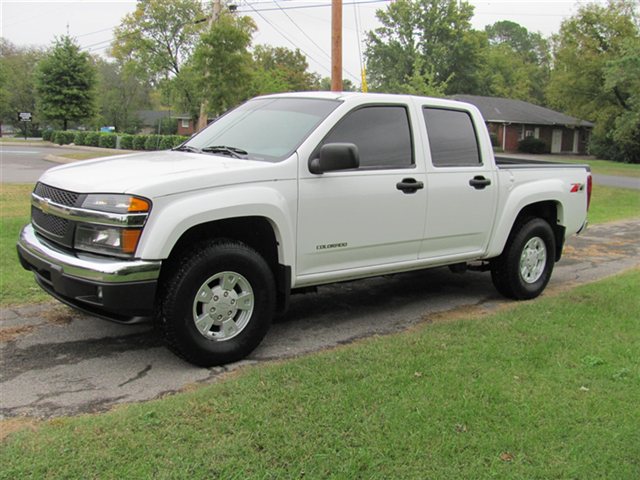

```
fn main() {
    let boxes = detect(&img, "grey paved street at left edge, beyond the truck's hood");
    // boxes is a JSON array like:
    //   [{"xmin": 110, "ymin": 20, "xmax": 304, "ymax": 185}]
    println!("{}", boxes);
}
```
[{"xmin": 0, "ymin": 143, "xmax": 76, "ymax": 183}]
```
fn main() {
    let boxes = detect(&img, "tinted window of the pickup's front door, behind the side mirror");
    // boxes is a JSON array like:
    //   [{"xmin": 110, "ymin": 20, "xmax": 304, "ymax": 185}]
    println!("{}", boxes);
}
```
[{"xmin": 322, "ymin": 106, "xmax": 413, "ymax": 168}]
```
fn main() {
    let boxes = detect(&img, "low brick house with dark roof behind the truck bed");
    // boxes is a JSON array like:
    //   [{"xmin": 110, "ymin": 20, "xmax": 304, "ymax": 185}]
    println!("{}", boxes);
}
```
[{"xmin": 452, "ymin": 95, "xmax": 594, "ymax": 155}]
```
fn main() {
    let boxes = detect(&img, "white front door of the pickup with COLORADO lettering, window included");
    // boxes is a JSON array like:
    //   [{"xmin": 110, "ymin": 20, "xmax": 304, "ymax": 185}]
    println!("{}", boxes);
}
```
[{"xmin": 297, "ymin": 103, "xmax": 426, "ymax": 281}]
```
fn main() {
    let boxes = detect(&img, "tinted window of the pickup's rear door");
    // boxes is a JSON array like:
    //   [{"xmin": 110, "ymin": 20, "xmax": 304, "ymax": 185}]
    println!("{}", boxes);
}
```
[{"xmin": 422, "ymin": 108, "xmax": 482, "ymax": 167}]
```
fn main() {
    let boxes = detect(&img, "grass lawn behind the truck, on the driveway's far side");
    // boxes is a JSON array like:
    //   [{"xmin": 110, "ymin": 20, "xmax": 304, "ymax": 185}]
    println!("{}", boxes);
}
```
[{"xmin": 0, "ymin": 184, "xmax": 640, "ymax": 306}]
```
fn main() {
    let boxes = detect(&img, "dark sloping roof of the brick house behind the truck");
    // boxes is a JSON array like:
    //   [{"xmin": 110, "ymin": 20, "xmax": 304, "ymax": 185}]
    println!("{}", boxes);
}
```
[{"xmin": 451, "ymin": 95, "xmax": 594, "ymax": 127}]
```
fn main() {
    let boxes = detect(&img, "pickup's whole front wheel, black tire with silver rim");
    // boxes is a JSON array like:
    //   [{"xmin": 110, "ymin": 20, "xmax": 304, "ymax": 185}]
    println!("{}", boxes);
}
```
[{"xmin": 158, "ymin": 241, "xmax": 276, "ymax": 367}]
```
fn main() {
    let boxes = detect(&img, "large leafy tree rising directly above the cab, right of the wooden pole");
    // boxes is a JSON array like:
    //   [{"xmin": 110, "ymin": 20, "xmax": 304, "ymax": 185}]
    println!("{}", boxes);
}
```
[{"xmin": 365, "ymin": 0, "xmax": 487, "ymax": 94}]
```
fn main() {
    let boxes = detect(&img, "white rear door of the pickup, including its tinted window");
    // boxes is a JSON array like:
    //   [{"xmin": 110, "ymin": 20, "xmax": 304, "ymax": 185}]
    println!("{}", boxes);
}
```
[{"xmin": 419, "ymin": 105, "xmax": 498, "ymax": 260}]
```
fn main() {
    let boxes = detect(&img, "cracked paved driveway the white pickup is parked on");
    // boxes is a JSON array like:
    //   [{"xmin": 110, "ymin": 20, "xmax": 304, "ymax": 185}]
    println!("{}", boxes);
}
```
[{"xmin": 0, "ymin": 220, "xmax": 640, "ymax": 418}]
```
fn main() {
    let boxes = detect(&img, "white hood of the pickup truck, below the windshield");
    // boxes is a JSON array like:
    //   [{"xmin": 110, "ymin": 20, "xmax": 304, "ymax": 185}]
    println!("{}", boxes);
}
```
[{"xmin": 40, "ymin": 151, "xmax": 296, "ymax": 198}]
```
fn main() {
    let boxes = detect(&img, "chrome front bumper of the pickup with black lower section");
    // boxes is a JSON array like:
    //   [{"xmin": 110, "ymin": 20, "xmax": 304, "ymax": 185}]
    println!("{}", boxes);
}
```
[{"xmin": 17, "ymin": 225, "xmax": 162, "ymax": 323}]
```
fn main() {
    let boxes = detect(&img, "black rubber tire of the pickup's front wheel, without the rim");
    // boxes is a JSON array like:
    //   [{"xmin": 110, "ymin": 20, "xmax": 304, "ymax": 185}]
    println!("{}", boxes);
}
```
[{"xmin": 163, "ymin": 243, "xmax": 275, "ymax": 366}]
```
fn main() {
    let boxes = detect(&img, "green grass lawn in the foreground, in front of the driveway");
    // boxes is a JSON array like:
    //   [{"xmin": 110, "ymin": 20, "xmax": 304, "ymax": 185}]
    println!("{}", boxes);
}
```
[{"xmin": 0, "ymin": 270, "xmax": 640, "ymax": 479}]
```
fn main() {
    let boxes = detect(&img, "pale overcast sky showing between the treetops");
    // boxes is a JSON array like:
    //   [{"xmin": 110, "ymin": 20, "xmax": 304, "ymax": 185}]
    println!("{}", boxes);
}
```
[{"xmin": 0, "ymin": 0, "xmax": 606, "ymax": 84}]
